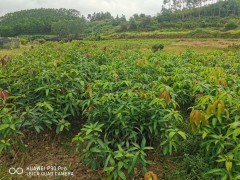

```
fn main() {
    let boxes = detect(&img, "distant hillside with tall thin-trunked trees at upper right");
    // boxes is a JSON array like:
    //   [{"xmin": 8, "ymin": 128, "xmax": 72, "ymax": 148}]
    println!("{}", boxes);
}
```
[{"xmin": 158, "ymin": 0, "xmax": 240, "ymax": 22}]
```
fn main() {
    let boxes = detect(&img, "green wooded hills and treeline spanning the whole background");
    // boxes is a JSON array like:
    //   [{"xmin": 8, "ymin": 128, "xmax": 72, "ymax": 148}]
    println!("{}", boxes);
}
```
[{"xmin": 0, "ymin": 0, "xmax": 240, "ymax": 39}]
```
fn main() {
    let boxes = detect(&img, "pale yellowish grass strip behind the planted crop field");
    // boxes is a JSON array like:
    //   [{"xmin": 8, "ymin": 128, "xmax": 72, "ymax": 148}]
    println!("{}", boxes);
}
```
[{"xmin": 0, "ymin": 38, "xmax": 240, "ymax": 58}]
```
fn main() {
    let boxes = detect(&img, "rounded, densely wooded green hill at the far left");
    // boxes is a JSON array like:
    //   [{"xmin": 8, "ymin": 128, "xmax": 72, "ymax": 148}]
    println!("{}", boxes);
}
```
[{"xmin": 0, "ymin": 8, "xmax": 82, "ymax": 36}]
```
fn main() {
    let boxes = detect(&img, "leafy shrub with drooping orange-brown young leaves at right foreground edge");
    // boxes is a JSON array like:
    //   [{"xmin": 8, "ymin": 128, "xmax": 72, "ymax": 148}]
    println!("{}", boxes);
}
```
[{"xmin": 190, "ymin": 81, "xmax": 240, "ymax": 179}]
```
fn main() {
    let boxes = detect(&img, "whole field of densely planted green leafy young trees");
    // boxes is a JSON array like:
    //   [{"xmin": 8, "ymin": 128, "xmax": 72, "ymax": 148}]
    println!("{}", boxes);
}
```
[{"xmin": 0, "ymin": 41, "xmax": 240, "ymax": 179}]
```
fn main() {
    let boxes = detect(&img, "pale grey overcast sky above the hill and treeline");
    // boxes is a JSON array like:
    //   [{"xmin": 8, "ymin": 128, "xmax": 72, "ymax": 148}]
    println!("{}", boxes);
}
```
[{"xmin": 0, "ymin": 0, "xmax": 163, "ymax": 17}]
